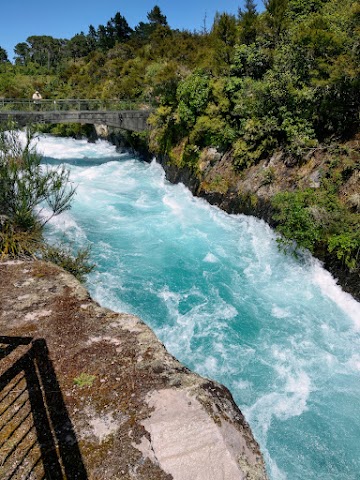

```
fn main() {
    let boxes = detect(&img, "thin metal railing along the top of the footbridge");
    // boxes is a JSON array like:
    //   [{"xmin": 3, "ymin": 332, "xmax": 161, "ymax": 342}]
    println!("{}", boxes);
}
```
[{"xmin": 0, "ymin": 98, "xmax": 140, "ymax": 112}]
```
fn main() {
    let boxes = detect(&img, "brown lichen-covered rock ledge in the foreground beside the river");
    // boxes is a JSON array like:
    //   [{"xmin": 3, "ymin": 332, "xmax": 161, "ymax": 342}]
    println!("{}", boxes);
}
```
[{"xmin": 0, "ymin": 261, "xmax": 267, "ymax": 480}]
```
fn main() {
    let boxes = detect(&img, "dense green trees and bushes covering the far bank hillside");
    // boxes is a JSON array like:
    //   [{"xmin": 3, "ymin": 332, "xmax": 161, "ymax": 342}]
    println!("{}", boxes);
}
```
[{"xmin": 0, "ymin": 0, "xmax": 360, "ymax": 297}]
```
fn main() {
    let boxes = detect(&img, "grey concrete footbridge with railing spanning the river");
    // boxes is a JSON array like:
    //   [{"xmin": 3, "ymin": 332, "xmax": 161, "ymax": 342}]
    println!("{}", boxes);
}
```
[{"xmin": 0, "ymin": 99, "xmax": 151, "ymax": 132}]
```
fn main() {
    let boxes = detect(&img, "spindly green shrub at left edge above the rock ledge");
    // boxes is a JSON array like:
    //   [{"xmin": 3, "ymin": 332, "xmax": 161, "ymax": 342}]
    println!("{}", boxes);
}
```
[{"xmin": 0, "ymin": 127, "xmax": 75, "ymax": 256}]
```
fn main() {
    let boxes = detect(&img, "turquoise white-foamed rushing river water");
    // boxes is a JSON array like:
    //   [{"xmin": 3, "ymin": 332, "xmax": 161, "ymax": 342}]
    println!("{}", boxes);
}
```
[{"xmin": 33, "ymin": 133, "xmax": 360, "ymax": 480}]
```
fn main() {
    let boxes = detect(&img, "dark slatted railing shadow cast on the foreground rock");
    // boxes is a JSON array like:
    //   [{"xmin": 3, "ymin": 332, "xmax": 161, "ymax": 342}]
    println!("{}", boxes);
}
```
[{"xmin": 0, "ymin": 336, "xmax": 88, "ymax": 480}]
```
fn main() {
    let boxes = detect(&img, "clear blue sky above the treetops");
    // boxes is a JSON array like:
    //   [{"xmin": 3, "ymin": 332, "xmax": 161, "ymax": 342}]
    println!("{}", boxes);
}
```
[{"xmin": 0, "ymin": 0, "xmax": 262, "ymax": 60}]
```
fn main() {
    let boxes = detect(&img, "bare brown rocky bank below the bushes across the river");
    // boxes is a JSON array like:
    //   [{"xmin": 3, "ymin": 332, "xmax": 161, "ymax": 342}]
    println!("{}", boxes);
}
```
[{"xmin": 158, "ymin": 141, "xmax": 360, "ymax": 301}]
